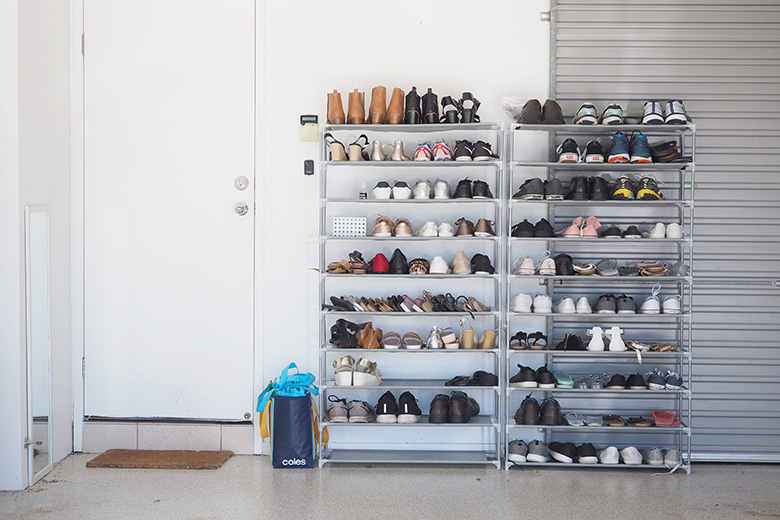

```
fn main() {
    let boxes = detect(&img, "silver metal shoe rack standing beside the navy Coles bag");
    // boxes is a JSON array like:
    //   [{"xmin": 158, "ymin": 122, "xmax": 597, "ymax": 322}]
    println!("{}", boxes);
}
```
[{"xmin": 319, "ymin": 123, "xmax": 508, "ymax": 467}]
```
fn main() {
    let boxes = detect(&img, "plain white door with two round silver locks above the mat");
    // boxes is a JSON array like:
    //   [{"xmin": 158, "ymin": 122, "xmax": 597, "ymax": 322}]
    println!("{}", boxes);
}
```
[{"xmin": 84, "ymin": 0, "xmax": 255, "ymax": 420}]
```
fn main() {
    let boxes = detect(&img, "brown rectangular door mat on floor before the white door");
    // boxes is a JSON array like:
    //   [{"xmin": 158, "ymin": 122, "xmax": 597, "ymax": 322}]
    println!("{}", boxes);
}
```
[{"xmin": 87, "ymin": 450, "xmax": 233, "ymax": 469}]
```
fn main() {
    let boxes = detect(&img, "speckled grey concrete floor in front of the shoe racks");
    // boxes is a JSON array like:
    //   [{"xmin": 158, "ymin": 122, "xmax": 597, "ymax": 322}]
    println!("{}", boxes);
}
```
[{"xmin": 0, "ymin": 454, "xmax": 780, "ymax": 520}]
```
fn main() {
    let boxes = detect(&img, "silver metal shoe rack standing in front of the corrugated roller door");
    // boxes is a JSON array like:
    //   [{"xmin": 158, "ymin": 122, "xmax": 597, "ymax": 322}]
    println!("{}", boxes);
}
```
[{"xmin": 503, "ymin": 125, "xmax": 696, "ymax": 473}]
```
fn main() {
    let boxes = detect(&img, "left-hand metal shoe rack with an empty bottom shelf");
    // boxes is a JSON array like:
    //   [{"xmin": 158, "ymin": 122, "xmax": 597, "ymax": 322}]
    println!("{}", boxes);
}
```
[{"xmin": 319, "ymin": 123, "xmax": 507, "ymax": 467}]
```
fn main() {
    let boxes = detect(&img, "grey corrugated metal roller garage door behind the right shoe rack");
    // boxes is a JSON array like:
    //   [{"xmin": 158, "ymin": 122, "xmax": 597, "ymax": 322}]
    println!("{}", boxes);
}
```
[{"xmin": 551, "ymin": 0, "xmax": 780, "ymax": 462}]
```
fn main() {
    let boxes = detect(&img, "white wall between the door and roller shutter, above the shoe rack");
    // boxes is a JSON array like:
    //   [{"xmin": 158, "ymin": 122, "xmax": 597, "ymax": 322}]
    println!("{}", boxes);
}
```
[{"xmin": 257, "ymin": 0, "xmax": 550, "ymax": 390}]
